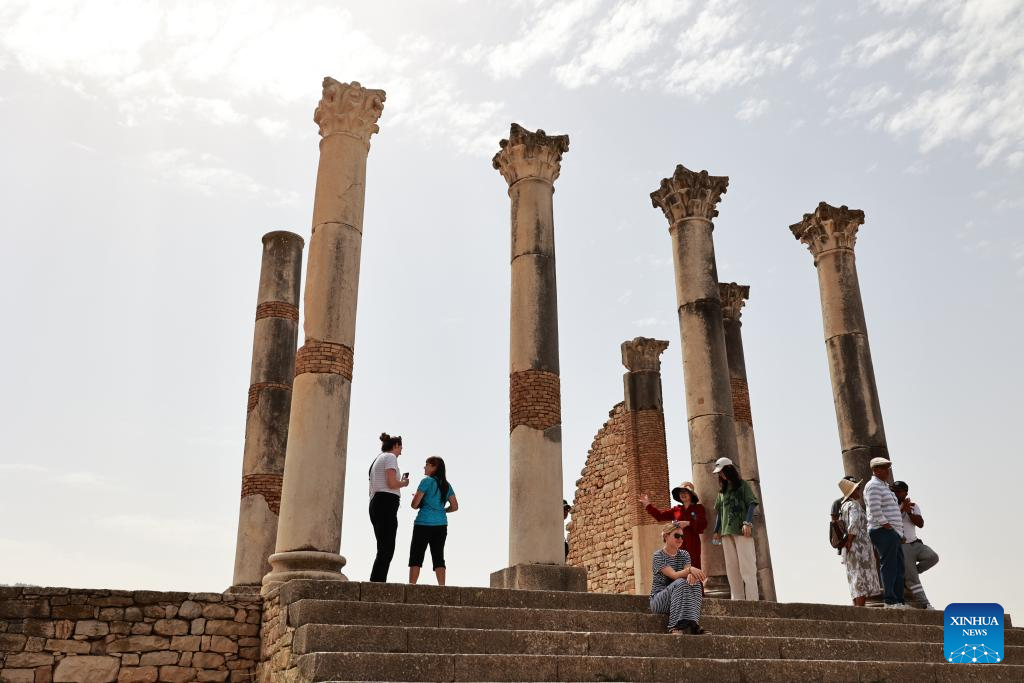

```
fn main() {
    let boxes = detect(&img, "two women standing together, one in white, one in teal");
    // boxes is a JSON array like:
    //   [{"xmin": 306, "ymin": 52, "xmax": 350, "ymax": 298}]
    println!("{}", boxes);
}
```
[{"xmin": 369, "ymin": 433, "xmax": 459, "ymax": 586}]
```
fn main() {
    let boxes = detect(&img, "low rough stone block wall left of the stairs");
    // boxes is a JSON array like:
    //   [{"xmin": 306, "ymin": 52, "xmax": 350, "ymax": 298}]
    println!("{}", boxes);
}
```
[{"xmin": 0, "ymin": 587, "xmax": 262, "ymax": 683}]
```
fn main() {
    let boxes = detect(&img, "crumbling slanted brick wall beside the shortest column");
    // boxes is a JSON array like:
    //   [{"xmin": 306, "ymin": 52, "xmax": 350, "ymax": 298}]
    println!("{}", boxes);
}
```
[{"xmin": 568, "ymin": 403, "xmax": 634, "ymax": 593}]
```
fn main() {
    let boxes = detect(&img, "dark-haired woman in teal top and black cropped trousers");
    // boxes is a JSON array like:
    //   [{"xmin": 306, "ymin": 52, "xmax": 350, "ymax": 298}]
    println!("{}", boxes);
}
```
[{"xmin": 409, "ymin": 456, "xmax": 459, "ymax": 586}]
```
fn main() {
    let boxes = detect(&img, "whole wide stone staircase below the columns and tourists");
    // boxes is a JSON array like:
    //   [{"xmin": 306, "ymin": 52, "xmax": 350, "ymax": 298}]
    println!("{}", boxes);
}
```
[{"xmin": 260, "ymin": 582, "xmax": 1024, "ymax": 683}]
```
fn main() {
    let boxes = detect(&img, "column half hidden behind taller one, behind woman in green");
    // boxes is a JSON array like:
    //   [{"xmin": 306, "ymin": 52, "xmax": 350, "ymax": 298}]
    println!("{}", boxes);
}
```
[{"xmin": 718, "ymin": 283, "xmax": 777, "ymax": 602}]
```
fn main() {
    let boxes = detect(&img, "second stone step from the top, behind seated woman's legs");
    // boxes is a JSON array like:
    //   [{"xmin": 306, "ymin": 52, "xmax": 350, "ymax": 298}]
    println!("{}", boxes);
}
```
[{"xmin": 289, "ymin": 599, "xmax": 1024, "ymax": 646}]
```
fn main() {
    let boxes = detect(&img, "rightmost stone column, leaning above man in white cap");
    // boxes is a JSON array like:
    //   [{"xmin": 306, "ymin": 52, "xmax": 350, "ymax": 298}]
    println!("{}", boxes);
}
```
[{"xmin": 790, "ymin": 202, "xmax": 889, "ymax": 480}]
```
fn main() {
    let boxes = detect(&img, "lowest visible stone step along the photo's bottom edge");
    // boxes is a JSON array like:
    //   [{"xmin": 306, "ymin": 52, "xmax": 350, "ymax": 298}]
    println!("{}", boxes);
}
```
[{"xmin": 298, "ymin": 652, "xmax": 1024, "ymax": 683}]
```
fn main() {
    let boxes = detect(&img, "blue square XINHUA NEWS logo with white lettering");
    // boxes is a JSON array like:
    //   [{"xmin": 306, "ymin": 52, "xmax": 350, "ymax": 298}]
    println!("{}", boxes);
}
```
[{"xmin": 943, "ymin": 602, "xmax": 1005, "ymax": 664}]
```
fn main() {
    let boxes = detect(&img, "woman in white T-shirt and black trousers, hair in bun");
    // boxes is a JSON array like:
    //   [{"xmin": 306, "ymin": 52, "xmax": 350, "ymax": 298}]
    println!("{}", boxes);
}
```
[{"xmin": 370, "ymin": 433, "xmax": 409, "ymax": 583}]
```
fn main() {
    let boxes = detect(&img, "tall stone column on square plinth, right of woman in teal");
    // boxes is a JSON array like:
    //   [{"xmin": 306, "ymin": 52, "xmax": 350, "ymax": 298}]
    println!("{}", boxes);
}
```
[{"xmin": 490, "ymin": 124, "xmax": 587, "ymax": 591}]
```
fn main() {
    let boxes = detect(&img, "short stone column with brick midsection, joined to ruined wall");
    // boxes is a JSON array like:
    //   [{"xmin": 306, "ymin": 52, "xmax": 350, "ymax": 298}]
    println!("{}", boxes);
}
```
[{"xmin": 622, "ymin": 337, "xmax": 672, "ymax": 595}]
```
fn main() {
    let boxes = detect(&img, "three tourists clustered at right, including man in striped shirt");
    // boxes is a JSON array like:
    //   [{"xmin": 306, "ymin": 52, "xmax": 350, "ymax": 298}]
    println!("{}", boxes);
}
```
[{"xmin": 837, "ymin": 458, "xmax": 939, "ymax": 609}]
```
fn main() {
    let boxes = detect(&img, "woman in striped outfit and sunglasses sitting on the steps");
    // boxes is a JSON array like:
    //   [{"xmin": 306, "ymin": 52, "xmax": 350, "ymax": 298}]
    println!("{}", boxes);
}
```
[{"xmin": 650, "ymin": 522, "xmax": 708, "ymax": 634}]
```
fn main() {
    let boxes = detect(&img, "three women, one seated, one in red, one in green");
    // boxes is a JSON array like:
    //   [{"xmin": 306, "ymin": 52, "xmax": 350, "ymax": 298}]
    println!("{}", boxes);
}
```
[{"xmin": 640, "ymin": 458, "xmax": 759, "ymax": 634}]
